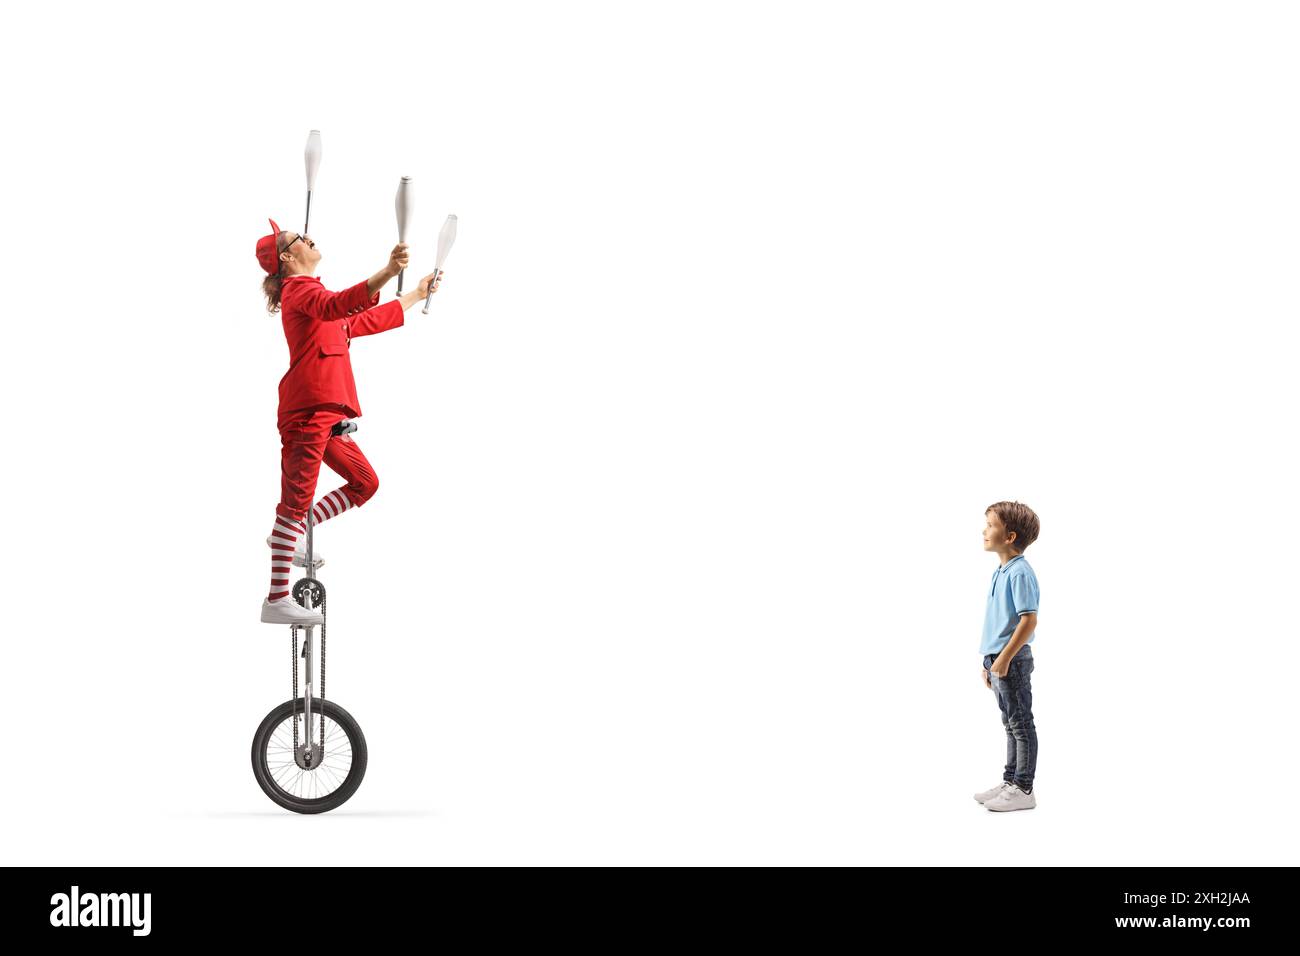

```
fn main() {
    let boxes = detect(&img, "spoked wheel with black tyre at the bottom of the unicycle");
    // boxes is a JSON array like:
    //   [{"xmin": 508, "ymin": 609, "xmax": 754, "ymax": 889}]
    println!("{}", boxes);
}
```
[{"xmin": 252, "ymin": 697, "xmax": 367, "ymax": 813}]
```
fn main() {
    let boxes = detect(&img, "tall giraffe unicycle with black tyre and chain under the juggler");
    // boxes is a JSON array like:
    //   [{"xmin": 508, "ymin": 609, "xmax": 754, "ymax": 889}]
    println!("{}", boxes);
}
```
[{"xmin": 252, "ymin": 419, "xmax": 367, "ymax": 813}]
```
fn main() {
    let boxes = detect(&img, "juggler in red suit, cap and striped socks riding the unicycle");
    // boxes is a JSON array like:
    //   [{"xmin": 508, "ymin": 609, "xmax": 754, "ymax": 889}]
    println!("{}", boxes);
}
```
[{"xmin": 257, "ymin": 220, "xmax": 442, "ymax": 624}]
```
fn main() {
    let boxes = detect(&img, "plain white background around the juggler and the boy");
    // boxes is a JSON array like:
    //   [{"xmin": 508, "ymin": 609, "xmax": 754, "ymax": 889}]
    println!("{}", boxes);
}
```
[{"xmin": 0, "ymin": 3, "xmax": 1300, "ymax": 865}]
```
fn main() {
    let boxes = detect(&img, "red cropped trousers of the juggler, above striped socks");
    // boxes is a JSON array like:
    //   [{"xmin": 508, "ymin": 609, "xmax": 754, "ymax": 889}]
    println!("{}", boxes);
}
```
[{"xmin": 276, "ymin": 405, "xmax": 380, "ymax": 522}]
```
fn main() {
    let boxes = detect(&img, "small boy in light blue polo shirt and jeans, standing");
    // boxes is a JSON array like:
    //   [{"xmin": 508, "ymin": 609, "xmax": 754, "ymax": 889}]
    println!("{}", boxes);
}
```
[{"xmin": 975, "ymin": 501, "xmax": 1039, "ymax": 810}]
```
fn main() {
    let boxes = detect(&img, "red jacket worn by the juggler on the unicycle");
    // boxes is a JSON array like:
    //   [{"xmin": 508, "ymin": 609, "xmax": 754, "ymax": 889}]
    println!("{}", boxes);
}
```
[{"xmin": 280, "ymin": 276, "xmax": 406, "ymax": 418}]
